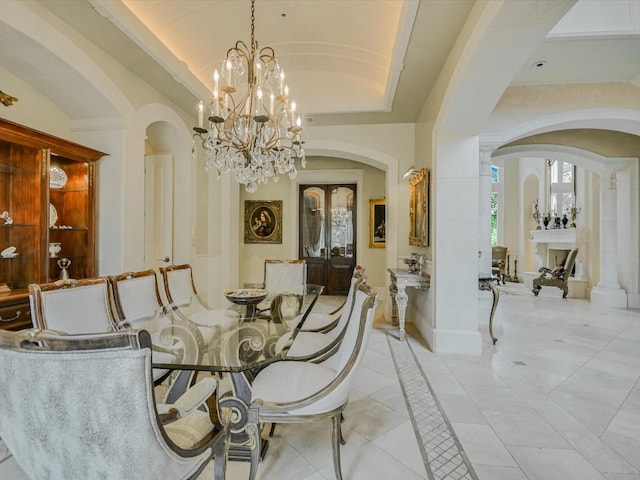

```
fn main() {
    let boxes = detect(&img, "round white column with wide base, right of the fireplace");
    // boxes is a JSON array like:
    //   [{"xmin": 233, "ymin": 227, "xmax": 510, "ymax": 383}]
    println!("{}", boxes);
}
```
[{"xmin": 591, "ymin": 169, "xmax": 627, "ymax": 308}]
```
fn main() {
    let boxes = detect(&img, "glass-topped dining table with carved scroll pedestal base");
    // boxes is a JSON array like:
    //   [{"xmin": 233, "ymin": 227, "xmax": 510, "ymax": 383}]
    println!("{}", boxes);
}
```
[{"xmin": 135, "ymin": 284, "xmax": 324, "ymax": 461}]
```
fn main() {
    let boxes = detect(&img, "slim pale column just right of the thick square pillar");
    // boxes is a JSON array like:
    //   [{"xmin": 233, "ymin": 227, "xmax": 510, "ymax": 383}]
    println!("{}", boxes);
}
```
[{"xmin": 478, "ymin": 146, "xmax": 494, "ymax": 273}]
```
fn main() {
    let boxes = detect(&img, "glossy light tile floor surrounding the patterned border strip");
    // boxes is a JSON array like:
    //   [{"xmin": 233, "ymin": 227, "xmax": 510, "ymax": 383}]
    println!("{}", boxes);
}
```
[{"xmin": 0, "ymin": 283, "xmax": 640, "ymax": 480}]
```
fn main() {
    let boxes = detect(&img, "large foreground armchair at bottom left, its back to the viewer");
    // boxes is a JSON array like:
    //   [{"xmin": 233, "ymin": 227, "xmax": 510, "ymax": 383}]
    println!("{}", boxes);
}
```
[{"xmin": 0, "ymin": 329, "xmax": 226, "ymax": 480}]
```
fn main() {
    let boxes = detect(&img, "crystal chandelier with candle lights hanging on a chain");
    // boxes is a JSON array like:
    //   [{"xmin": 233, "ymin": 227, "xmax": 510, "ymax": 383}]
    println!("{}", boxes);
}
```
[{"xmin": 193, "ymin": 0, "xmax": 306, "ymax": 193}]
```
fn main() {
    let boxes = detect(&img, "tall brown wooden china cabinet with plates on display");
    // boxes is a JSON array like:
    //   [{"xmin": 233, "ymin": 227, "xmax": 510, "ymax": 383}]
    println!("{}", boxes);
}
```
[{"xmin": 0, "ymin": 119, "xmax": 106, "ymax": 330}]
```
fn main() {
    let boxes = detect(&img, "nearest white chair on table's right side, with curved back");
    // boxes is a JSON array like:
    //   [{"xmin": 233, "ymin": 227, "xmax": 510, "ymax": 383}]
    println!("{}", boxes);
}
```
[{"xmin": 249, "ymin": 284, "xmax": 377, "ymax": 480}]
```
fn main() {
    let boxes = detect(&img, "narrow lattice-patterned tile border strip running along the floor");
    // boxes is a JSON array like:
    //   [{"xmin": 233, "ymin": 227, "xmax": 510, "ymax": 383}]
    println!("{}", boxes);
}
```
[{"xmin": 387, "ymin": 334, "xmax": 478, "ymax": 480}]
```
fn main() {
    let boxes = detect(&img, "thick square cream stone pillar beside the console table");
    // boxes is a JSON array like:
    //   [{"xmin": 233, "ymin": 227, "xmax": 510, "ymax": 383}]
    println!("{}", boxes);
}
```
[{"xmin": 424, "ymin": 135, "xmax": 482, "ymax": 355}]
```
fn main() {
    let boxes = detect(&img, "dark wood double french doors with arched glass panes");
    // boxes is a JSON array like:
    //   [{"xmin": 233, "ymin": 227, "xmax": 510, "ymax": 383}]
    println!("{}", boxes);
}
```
[{"xmin": 298, "ymin": 184, "xmax": 357, "ymax": 295}]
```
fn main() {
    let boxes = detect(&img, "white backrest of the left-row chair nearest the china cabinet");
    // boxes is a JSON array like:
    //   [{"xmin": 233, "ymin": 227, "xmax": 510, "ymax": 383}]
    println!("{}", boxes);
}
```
[{"xmin": 29, "ymin": 277, "xmax": 119, "ymax": 333}]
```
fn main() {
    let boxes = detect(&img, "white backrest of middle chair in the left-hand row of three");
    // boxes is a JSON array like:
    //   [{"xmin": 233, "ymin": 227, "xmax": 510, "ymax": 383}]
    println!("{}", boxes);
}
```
[{"xmin": 109, "ymin": 270, "xmax": 162, "ymax": 322}]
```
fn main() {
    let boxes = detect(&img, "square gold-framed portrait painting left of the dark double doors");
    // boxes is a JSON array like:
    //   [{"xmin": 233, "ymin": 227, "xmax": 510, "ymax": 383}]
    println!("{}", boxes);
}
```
[{"xmin": 244, "ymin": 200, "xmax": 282, "ymax": 243}]
